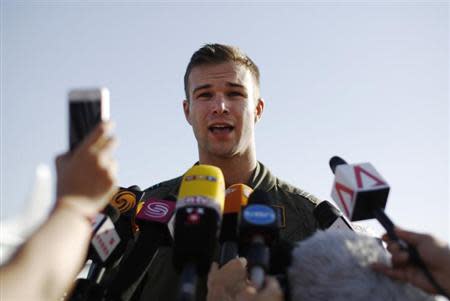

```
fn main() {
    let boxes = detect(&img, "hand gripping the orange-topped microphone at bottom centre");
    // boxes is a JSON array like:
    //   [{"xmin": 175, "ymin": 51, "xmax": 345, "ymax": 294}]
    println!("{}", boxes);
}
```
[{"xmin": 207, "ymin": 257, "xmax": 248, "ymax": 301}]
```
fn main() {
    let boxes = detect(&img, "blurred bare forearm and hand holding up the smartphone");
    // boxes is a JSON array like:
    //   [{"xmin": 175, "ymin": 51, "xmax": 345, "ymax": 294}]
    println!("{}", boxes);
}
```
[{"xmin": 0, "ymin": 123, "xmax": 117, "ymax": 301}]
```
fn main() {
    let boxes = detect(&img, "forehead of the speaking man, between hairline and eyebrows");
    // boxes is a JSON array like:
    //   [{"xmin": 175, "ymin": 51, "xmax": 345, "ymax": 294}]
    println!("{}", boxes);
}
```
[{"xmin": 189, "ymin": 62, "xmax": 253, "ymax": 90}]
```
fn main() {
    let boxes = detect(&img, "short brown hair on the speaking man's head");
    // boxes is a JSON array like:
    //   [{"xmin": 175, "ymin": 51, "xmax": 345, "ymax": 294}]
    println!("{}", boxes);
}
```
[{"xmin": 184, "ymin": 44, "xmax": 259, "ymax": 100}]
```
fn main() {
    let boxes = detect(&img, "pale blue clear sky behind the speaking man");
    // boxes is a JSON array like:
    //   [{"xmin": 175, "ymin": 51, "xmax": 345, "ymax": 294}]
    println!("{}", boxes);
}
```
[{"xmin": 0, "ymin": 0, "xmax": 450, "ymax": 241}]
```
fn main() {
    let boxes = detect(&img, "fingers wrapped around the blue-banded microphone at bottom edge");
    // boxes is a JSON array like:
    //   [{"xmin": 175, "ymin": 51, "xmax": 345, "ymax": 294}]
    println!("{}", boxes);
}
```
[{"xmin": 236, "ymin": 276, "xmax": 284, "ymax": 301}]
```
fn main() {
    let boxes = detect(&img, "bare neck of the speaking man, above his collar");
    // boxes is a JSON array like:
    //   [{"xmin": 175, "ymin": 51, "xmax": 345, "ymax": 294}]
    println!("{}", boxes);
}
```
[{"xmin": 199, "ymin": 156, "xmax": 257, "ymax": 188}]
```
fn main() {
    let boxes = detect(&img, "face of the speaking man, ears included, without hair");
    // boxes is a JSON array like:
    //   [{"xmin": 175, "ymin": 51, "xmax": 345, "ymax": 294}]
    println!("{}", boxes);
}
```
[{"xmin": 183, "ymin": 62, "xmax": 264, "ymax": 158}]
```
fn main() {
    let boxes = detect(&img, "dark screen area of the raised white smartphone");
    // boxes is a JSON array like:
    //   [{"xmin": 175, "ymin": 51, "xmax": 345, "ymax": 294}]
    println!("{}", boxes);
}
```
[{"xmin": 69, "ymin": 99, "xmax": 102, "ymax": 150}]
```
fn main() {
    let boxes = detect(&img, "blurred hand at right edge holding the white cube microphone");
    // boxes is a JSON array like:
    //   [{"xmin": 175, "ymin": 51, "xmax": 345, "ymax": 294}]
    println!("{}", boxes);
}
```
[{"xmin": 372, "ymin": 228, "xmax": 450, "ymax": 294}]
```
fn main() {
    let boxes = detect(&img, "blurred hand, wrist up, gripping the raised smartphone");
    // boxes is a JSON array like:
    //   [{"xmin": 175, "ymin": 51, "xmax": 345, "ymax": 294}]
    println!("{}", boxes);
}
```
[{"xmin": 56, "ymin": 122, "xmax": 117, "ymax": 217}]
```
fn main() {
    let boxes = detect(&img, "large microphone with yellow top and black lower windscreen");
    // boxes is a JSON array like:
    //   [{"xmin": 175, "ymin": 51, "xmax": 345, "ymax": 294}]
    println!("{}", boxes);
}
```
[{"xmin": 173, "ymin": 165, "xmax": 225, "ymax": 300}]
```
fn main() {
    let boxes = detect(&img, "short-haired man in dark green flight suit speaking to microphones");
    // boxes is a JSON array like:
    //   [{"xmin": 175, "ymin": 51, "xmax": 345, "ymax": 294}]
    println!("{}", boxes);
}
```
[{"xmin": 128, "ymin": 44, "xmax": 318, "ymax": 300}]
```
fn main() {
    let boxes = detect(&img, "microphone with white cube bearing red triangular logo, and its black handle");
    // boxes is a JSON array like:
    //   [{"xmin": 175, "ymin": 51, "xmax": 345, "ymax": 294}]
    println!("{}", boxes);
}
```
[{"xmin": 330, "ymin": 156, "xmax": 448, "ymax": 296}]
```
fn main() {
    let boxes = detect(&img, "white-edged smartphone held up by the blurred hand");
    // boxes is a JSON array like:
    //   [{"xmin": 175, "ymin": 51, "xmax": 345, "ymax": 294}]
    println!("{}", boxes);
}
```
[{"xmin": 68, "ymin": 88, "xmax": 110, "ymax": 151}]
